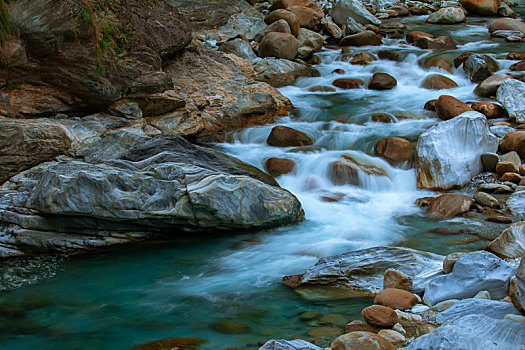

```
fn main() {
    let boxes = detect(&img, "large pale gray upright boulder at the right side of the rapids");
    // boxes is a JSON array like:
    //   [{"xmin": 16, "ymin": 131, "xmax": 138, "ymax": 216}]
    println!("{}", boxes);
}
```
[{"xmin": 416, "ymin": 112, "xmax": 499, "ymax": 190}]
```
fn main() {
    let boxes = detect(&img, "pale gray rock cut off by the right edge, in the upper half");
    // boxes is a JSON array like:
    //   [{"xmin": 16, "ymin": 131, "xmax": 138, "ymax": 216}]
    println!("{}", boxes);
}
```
[{"xmin": 496, "ymin": 79, "xmax": 525, "ymax": 123}]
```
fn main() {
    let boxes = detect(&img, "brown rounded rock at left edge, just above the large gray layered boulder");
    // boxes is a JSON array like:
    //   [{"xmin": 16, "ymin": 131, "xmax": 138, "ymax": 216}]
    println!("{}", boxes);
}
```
[{"xmin": 0, "ymin": 118, "xmax": 71, "ymax": 184}]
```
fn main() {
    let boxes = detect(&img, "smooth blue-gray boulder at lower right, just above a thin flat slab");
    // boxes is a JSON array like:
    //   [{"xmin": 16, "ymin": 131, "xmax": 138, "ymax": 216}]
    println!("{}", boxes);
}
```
[{"xmin": 423, "ymin": 251, "xmax": 515, "ymax": 306}]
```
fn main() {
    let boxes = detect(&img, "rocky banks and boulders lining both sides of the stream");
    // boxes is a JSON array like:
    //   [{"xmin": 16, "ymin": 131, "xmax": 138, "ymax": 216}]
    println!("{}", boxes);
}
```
[{"xmin": 0, "ymin": 0, "xmax": 525, "ymax": 350}]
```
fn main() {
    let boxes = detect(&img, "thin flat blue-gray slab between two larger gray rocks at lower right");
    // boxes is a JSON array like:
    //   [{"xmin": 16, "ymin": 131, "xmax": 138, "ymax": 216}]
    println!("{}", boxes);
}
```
[{"xmin": 436, "ymin": 298, "xmax": 520, "ymax": 323}]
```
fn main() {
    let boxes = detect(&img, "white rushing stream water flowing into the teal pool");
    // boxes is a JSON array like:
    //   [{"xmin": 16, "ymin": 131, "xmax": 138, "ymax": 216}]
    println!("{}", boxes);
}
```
[{"xmin": 0, "ymin": 12, "xmax": 519, "ymax": 349}]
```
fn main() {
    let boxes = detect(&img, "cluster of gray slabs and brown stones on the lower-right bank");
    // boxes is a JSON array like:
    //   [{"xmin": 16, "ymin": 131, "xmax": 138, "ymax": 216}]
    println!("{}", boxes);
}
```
[{"xmin": 261, "ymin": 239, "xmax": 525, "ymax": 350}]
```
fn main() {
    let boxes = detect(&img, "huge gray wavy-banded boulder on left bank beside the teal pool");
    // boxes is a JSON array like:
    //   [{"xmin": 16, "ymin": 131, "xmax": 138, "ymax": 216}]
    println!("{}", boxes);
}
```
[{"xmin": 0, "ymin": 131, "xmax": 302, "ymax": 255}]
